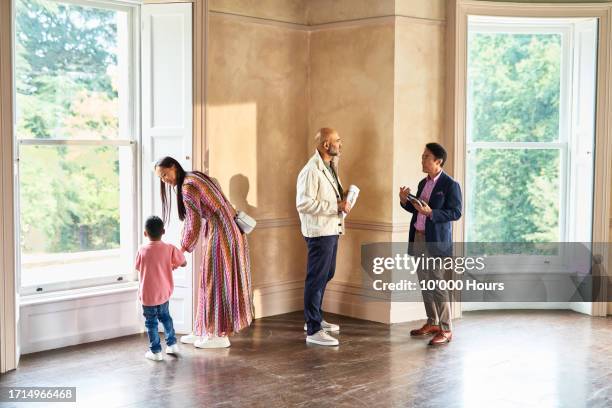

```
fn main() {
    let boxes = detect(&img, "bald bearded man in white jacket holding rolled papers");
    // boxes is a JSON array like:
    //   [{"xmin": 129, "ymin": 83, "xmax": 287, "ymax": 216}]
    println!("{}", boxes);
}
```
[{"xmin": 295, "ymin": 128, "xmax": 351, "ymax": 346}]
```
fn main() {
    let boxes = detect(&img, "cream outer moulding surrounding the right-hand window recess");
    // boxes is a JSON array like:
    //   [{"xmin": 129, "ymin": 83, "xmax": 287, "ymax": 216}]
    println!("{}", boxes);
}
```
[{"xmin": 452, "ymin": 0, "xmax": 612, "ymax": 317}]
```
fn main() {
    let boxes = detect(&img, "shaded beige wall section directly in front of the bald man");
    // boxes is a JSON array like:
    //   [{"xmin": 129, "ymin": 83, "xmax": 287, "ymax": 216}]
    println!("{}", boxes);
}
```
[{"xmin": 308, "ymin": 22, "xmax": 394, "ymax": 321}]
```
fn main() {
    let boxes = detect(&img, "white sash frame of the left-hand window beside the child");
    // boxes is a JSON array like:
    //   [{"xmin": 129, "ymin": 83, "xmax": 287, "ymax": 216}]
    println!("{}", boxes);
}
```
[{"xmin": 12, "ymin": 0, "xmax": 141, "ymax": 296}]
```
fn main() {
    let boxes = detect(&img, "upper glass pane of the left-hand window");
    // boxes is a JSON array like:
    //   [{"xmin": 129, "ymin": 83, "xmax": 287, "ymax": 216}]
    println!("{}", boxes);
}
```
[{"xmin": 15, "ymin": 0, "xmax": 129, "ymax": 139}]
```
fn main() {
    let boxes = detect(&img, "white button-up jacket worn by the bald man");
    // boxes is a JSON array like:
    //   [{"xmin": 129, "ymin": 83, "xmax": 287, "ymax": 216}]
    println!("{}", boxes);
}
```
[{"xmin": 295, "ymin": 151, "xmax": 344, "ymax": 238}]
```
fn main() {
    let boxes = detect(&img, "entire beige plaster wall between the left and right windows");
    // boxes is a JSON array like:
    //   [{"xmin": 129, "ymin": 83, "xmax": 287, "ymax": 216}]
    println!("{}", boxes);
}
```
[{"xmin": 207, "ymin": 0, "xmax": 452, "ymax": 322}]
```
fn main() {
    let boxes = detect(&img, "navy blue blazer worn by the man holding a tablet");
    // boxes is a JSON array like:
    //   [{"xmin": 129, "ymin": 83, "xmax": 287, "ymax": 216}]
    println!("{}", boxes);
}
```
[{"xmin": 402, "ymin": 171, "xmax": 462, "ymax": 256}]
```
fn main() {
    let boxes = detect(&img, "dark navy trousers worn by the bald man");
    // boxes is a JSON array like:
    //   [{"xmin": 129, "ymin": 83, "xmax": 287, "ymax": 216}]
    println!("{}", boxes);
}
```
[{"xmin": 304, "ymin": 235, "xmax": 338, "ymax": 336}]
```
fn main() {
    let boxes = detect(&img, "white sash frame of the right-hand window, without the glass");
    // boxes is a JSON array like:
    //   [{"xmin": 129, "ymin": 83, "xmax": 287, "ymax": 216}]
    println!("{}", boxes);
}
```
[{"xmin": 464, "ymin": 15, "xmax": 597, "ymax": 273}]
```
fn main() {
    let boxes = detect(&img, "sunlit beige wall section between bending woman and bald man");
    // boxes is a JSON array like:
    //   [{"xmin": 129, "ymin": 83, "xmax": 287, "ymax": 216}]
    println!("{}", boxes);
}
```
[{"xmin": 206, "ymin": 13, "xmax": 308, "ymax": 317}]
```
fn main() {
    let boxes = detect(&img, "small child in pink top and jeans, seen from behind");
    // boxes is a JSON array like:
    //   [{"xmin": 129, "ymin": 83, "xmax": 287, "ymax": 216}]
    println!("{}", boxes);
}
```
[{"xmin": 136, "ymin": 216, "xmax": 187, "ymax": 361}]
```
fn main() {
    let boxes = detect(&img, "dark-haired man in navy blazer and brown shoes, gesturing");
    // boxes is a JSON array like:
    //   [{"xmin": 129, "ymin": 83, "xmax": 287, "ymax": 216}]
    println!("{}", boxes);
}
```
[{"xmin": 399, "ymin": 143, "xmax": 461, "ymax": 345}]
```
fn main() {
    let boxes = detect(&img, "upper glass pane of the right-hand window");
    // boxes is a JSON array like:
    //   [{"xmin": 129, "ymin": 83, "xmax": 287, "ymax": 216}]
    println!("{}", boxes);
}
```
[{"xmin": 467, "ymin": 32, "xmax": 561, "ymax": 142}]
